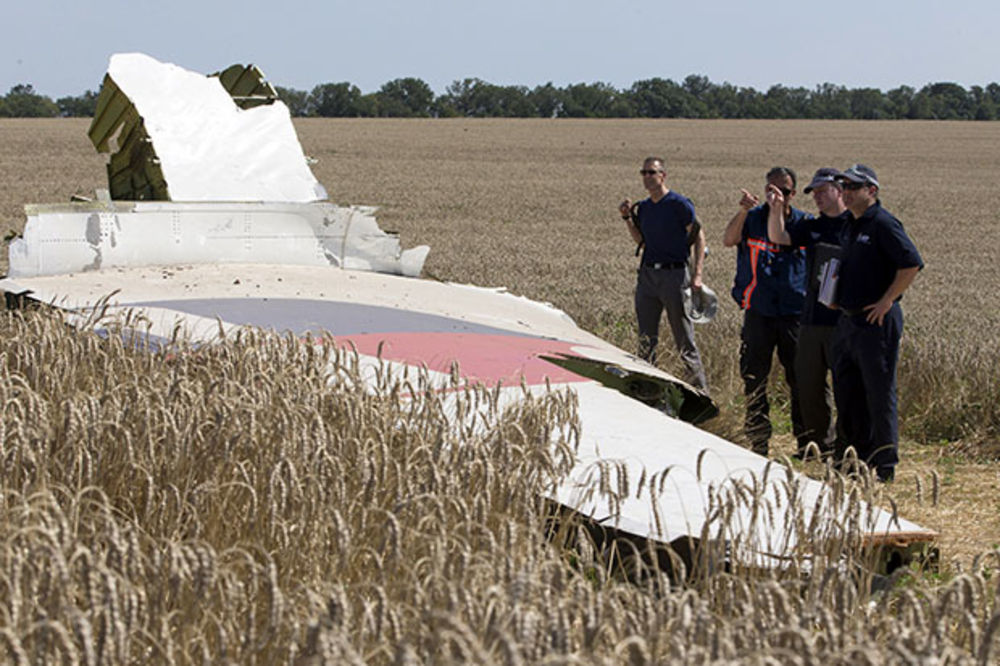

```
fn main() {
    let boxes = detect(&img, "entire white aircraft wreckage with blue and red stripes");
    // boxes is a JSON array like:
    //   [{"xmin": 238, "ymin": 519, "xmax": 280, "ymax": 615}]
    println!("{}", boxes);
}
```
[{"xmin": 0, "ymin": 54, "xmax": 936, "ymax": 566}]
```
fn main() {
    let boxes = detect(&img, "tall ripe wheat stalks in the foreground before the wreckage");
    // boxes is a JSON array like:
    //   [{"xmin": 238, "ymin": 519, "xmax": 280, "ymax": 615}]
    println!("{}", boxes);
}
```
[{"xmin": 0, "ymin": 312, "xmax": 1000, "ymax": 664}]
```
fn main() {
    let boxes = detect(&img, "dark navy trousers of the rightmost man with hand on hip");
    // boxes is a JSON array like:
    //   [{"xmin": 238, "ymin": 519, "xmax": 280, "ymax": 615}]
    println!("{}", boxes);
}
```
[{"xmin": 833, "ymin": 303, "xmax": 903, "ymax": 468}]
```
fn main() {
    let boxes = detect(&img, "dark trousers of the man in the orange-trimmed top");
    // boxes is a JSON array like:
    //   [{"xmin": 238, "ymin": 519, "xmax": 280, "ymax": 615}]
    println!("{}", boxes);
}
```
[{"xmin": 740, "ymin": 310, "xmax": 805, "ymax": 455}]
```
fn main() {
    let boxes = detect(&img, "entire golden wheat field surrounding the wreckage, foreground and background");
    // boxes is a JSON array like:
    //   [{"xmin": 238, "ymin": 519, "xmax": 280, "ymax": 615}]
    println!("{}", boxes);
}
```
[{"xmin": 0, "ymin": 119, "xmax": 1000, "ymax": 664}]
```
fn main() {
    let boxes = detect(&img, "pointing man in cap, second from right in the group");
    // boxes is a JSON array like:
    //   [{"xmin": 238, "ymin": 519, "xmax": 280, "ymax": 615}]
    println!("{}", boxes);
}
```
[{"xmin": 767, "ymin": 167, "xmax": 849, "ymax": 458}]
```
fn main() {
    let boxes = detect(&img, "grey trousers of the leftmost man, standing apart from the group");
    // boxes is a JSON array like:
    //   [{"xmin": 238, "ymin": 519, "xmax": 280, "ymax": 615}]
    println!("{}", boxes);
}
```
[{"xmin": 635, "ymin": 266, "xmax": 708, "ymax": 391}]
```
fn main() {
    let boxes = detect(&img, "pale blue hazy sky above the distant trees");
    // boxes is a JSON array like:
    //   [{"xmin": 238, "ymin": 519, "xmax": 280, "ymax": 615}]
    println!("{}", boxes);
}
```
[{"xmin": 0, "ymin": 0, "xmax": 1000, "ymax": 99}]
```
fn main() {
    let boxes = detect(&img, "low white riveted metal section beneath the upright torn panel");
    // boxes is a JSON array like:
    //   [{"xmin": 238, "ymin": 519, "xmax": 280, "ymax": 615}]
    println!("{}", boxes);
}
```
[{"xmin": 9, "ymin": 201, "xmax": 430, "ymax": 278}]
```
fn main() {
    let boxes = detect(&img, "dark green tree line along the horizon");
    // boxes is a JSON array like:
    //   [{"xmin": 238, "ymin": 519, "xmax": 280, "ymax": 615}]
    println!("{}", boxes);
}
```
[{"xmin": 0, "ymin": 74, "xmax": 1000, "ymax": 120}]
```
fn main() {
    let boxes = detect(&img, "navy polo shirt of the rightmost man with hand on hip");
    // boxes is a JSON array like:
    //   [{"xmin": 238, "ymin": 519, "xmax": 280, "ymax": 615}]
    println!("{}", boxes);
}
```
[{"xmin": 837, "ymin": 201, "xmax": 924, "ymax": 310}]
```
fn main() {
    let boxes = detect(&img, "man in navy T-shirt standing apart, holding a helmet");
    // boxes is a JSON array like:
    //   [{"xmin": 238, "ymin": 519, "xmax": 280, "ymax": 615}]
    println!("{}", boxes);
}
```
[{"xmin": 618, "ymin": 157, "xmax": 708, "ymax": 391}]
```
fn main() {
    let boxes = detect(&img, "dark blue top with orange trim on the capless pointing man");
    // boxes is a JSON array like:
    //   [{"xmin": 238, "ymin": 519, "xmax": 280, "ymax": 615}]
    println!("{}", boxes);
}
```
[{"xmin": 732, "ymin": 204, "xmax": 812, "ymax": 317}]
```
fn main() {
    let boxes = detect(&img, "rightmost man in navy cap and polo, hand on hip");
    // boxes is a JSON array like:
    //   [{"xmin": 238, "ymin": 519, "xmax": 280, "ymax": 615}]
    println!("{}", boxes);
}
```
[{"xmin": 833, "ymin": 164, "xmax": 924, "ymax": 481}]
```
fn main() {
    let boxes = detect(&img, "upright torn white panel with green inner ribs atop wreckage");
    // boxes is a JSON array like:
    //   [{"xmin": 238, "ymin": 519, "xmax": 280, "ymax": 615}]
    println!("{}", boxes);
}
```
[{"xmin": 88, "ymin": 53, "xmax": 327, "ymax": 202}]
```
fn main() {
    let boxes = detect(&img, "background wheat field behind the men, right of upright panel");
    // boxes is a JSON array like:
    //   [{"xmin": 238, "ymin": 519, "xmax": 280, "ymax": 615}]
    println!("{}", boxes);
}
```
[{"xmin": 298, "ymin": 120, "xmax": 1000, "ymax": 448}]
